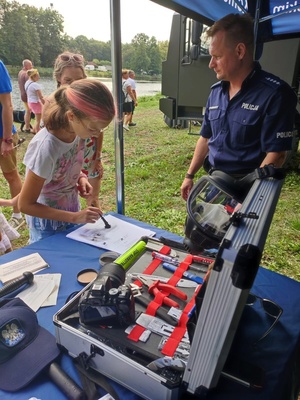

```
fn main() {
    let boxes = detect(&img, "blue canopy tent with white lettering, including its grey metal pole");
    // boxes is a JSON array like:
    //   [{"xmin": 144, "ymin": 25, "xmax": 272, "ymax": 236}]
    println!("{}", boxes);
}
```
[{"xmin": 110, "ymin": 0, "xmax": 300, "ymax": 214}]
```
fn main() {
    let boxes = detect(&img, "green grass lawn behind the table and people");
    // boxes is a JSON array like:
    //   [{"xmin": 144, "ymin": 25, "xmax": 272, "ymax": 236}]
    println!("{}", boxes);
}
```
[{"xmin": 0, "ymin": 96, "xmax": 300, "ymax": 280}]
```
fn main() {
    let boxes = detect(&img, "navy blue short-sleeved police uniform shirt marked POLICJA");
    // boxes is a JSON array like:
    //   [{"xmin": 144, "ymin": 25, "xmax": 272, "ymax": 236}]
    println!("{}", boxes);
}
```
[{"xmin": 200, "ymin": 63, "xmax": 297, "ymax": 174}]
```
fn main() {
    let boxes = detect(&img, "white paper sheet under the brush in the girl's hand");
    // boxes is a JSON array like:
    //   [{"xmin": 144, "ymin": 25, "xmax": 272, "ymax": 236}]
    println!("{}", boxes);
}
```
[{"xmin": 67, "ymin": 215, "xmax": 155, "ymax": 254}]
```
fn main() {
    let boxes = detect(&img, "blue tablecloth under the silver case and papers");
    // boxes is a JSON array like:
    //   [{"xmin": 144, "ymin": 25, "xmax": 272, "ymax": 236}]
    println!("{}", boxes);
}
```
[{"xmin": 0, "ymin": 213, "xmax": 300, "ymax": 400}]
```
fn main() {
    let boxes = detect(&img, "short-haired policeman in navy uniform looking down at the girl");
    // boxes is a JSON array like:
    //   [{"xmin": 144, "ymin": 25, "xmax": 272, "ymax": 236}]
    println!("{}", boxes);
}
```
[{"xmin": 181, "ymin": 14, "xmax": 297, "ymax": 200}]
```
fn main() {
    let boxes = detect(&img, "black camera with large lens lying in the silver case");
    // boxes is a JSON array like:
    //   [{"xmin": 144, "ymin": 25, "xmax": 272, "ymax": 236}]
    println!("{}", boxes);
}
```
[{"xmin": 78, "ymin": 263, "xmax": 135, "ymax": 327}]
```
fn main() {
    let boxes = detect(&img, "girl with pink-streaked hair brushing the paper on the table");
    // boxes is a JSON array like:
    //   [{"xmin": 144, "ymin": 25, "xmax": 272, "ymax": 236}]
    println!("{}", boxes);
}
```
[{"xmin": 19, "ymin": 79, "xmax": 115, "ymax": 243}]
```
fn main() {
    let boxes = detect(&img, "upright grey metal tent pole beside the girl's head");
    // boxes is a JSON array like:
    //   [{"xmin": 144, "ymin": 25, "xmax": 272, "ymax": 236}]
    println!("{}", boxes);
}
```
[{"xmin": 110, "ymin": 0, "xmax": 125, "ymax": 214}]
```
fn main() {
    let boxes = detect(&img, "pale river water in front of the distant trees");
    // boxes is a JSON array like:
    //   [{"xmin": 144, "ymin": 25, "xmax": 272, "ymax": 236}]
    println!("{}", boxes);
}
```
[{"xmin": 12, "ymin": 78, "xmax": 161, "ymax": 110}]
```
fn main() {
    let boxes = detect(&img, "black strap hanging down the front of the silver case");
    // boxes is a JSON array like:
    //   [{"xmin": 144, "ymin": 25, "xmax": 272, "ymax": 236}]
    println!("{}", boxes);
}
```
[{"xmin": 74, "ymin": 352, "xmax": 119, "ymax": 400}]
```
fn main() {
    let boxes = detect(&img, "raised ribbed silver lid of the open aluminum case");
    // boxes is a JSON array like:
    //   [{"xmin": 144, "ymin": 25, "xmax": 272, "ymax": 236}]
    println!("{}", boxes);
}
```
[{"xmin": 183, "ymin": 173, "xmax": 284, "ymax": 395}]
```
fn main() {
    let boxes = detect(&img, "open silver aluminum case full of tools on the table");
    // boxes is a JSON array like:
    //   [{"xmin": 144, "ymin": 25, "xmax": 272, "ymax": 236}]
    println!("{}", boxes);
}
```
[{"xmin": 54, "ymin": 178, "xmax": 284, "ymax": 400}]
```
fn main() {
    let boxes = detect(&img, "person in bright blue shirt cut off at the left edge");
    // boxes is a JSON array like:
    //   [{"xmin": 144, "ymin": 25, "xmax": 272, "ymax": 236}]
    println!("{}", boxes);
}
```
[{"xmin": 0, "ymin": 61, "xmax": 25, "ymax": 229}]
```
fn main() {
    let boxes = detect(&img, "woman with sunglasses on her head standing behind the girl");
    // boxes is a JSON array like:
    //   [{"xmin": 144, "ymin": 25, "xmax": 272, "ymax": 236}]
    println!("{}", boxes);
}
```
[{"xmin": 53, "ymin": 51, "xmax": 103, "ymax": 208}]
